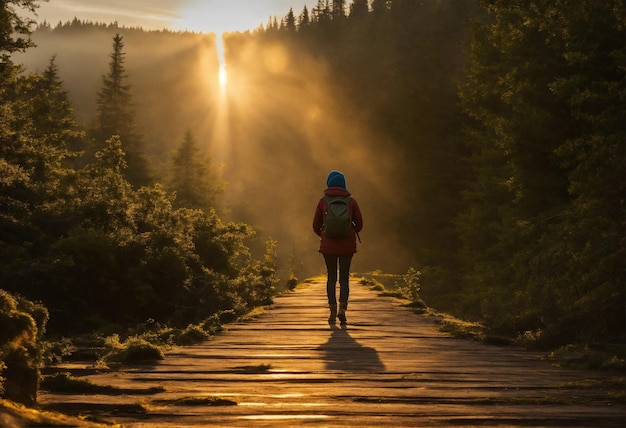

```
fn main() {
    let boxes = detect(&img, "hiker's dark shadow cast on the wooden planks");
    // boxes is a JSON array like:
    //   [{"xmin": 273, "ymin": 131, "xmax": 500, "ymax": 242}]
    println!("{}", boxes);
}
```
[{"xmin": 318, "ymin": 324, "xmax": 385, "ymax": 372}]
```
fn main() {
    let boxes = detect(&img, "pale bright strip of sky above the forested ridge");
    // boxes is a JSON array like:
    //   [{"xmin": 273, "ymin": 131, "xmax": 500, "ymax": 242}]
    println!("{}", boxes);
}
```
[{"xmin": 37, "ymin": 0, "xmax": 326, "ymax": 36}]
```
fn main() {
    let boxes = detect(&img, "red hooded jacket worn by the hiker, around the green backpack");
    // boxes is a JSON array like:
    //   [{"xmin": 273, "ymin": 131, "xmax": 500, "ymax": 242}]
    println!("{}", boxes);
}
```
[{"xmin": 313, "ymin": 187, "xmax": 363, "ymax": 256}]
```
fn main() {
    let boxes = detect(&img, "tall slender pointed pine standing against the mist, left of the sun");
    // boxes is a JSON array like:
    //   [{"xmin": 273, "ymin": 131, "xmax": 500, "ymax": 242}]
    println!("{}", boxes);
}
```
[{"xmin": 95, "ymin": 34, "xmax": 152, "ymax": 187}]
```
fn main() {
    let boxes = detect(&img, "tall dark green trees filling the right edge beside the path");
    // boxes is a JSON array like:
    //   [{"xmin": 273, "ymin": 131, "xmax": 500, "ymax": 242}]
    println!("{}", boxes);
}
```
[{"xmin": 457, "ymin": 0, "xmax": 625, "ymax": 345}]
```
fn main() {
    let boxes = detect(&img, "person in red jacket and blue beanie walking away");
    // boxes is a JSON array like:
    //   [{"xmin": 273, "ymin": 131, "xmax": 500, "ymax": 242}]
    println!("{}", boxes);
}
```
[{"xmin": 313, "ymin": 170, "xmax": 363, "ymax": 324}]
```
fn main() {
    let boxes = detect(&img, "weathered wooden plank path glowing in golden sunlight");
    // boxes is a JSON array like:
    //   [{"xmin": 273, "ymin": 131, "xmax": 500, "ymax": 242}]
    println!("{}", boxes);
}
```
[{"xmin": 39, "ymin": 282, "xmax": 626, "ymax": 428}]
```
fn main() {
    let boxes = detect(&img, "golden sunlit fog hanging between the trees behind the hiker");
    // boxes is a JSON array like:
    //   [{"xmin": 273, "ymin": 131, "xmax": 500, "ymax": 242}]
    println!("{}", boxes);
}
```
[{"xmin": 17, "ymin": 26, "xmax": 414, "ymax": 274}]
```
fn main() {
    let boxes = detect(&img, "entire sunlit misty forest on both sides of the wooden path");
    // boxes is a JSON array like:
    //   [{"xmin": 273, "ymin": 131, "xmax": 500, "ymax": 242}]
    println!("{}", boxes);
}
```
[{"xmin": 0, "ymin": 0, "xmax": 626, "ymax": 408}]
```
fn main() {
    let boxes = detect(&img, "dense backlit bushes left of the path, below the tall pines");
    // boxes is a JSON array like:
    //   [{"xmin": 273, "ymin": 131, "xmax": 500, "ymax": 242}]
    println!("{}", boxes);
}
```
[{"xmin": 2, "ymin": 88, "xmax": 276, "ymax": 333}]
